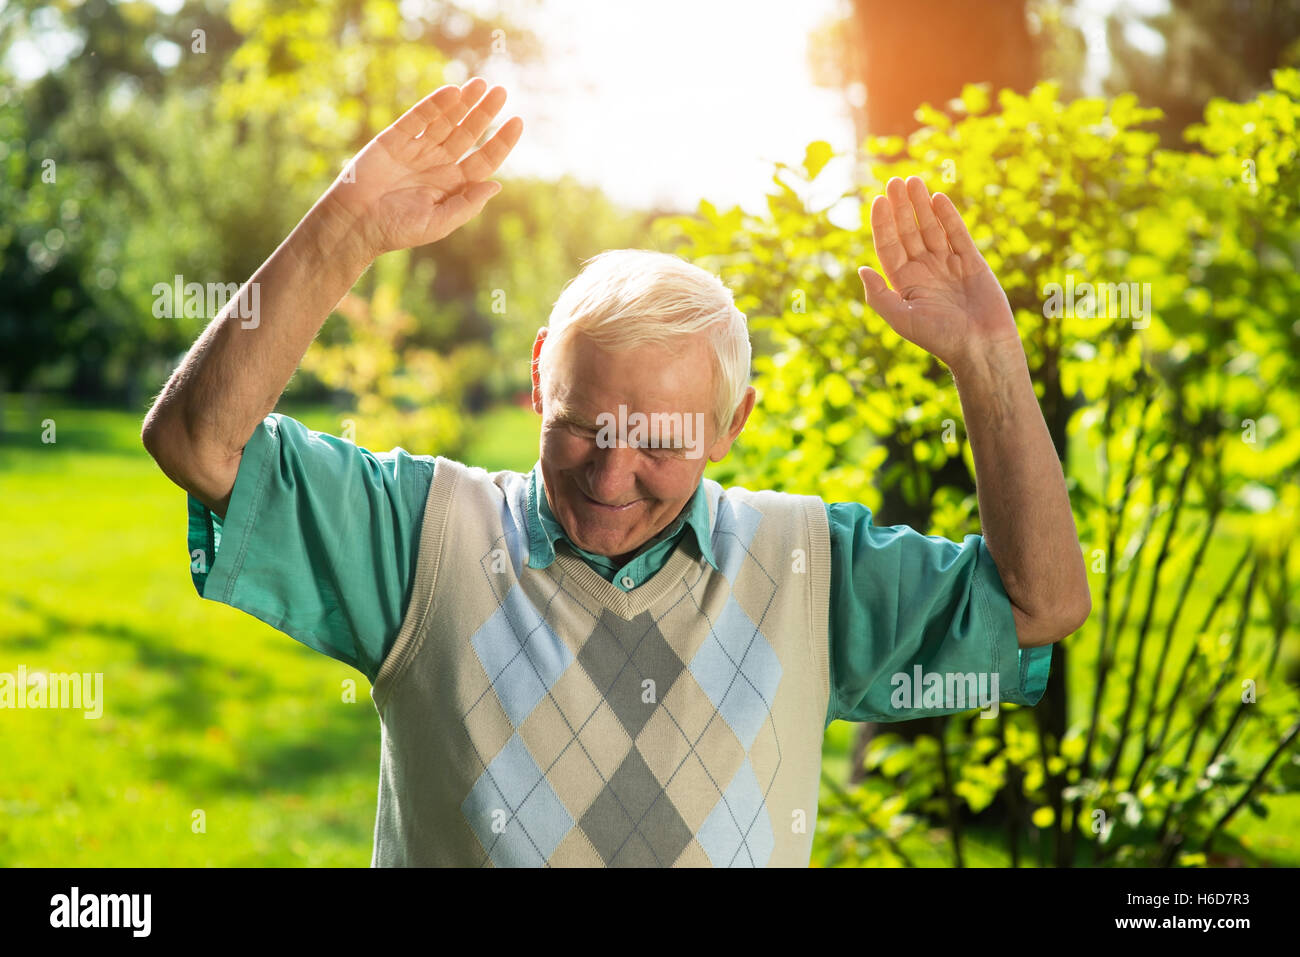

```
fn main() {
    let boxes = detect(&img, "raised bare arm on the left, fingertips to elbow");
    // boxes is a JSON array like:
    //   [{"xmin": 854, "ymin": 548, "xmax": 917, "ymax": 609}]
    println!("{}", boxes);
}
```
[{"xmin": 140, "ymin": 78, "xmax": 523, "ymax": 519}]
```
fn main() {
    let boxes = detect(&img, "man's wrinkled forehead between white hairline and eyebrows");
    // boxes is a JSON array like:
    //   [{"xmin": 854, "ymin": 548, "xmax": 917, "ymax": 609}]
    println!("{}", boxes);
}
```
[{"xmin": 546, "ymin": 328, "xmax": 716, "ymax": 415}]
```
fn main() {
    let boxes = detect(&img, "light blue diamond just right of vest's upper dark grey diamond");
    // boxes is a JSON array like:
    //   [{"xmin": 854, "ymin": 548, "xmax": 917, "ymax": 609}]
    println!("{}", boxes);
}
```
[{"xmin": 690, "ymin": 596, "xmax": 781, "ymax": 752}]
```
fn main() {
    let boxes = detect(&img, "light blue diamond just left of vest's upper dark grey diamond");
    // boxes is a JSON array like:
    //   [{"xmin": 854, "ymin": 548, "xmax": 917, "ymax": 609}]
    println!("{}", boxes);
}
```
[{"xmin": 469, "ymin": 583, "xmax": 573, "ymax": 728}]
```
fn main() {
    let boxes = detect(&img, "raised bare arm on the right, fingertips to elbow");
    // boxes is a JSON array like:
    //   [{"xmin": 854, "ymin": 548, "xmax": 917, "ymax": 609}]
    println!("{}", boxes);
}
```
[{"xmin": 858, "ymin": 177, "xmax": 1092, "ymax": 648}]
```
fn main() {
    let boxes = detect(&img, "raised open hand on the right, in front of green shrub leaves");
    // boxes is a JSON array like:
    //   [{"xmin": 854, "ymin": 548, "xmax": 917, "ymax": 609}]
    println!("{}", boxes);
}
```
[{"xmin": 858, "ymin": 176, "xmax": 1021, "ymax": 368}]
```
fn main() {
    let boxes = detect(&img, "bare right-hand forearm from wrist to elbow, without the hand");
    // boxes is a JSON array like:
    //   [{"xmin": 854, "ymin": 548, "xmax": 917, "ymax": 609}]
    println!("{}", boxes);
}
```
[{"xmin": 953, "ymin": 343, "xmax": 1091, "ymax": 644}]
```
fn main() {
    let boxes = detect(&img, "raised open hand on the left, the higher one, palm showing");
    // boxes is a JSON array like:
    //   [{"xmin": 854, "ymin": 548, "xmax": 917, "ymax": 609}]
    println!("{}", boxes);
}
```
[{"xmin": 329, "ymin": 77, "xmax": 524, "ymax": 256}]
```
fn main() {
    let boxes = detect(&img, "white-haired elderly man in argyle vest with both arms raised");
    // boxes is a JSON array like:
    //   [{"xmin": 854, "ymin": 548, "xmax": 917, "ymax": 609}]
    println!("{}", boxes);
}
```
[{"xmin": 143, "ymin": 78, "xmax": 1091, "ymax": 866}]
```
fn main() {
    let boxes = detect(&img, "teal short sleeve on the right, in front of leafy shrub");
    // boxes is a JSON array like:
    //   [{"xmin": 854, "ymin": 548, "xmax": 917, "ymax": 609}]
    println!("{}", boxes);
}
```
[{"xmin": 826, "ymin": 502, "xmax": 1052, "ymax": 726}]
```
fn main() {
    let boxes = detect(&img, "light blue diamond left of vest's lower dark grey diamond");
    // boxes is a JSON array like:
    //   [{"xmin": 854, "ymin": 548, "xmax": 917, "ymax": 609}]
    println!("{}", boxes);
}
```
[{"xmin": 460, "ymin": 733, "xmax": 573, "ymax": 867}]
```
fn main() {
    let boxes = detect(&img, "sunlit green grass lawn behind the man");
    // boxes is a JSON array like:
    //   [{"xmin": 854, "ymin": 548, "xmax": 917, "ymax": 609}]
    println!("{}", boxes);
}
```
[{"xmin": 0, "ymin": 397, "xmax": 1300, "ymax": 867}]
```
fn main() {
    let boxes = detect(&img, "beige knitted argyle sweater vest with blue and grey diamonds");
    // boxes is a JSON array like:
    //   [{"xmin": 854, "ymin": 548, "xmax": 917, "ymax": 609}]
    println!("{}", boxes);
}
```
[{"xmin": 371, "ymin": 458, "xmax": 831, "ymax": 867}]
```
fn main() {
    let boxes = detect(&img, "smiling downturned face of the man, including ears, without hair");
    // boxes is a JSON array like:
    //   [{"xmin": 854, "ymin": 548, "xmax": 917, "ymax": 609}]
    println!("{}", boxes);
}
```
[{"xmin": 533, "ymin": 330, "xmax": 753, "ymax": 560}]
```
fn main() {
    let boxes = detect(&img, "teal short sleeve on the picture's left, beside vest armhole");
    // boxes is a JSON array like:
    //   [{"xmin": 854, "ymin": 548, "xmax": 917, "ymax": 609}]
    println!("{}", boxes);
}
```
[{"xmin": 187, "ymin": 412, "xmax": 434, "ymax": 683}]
